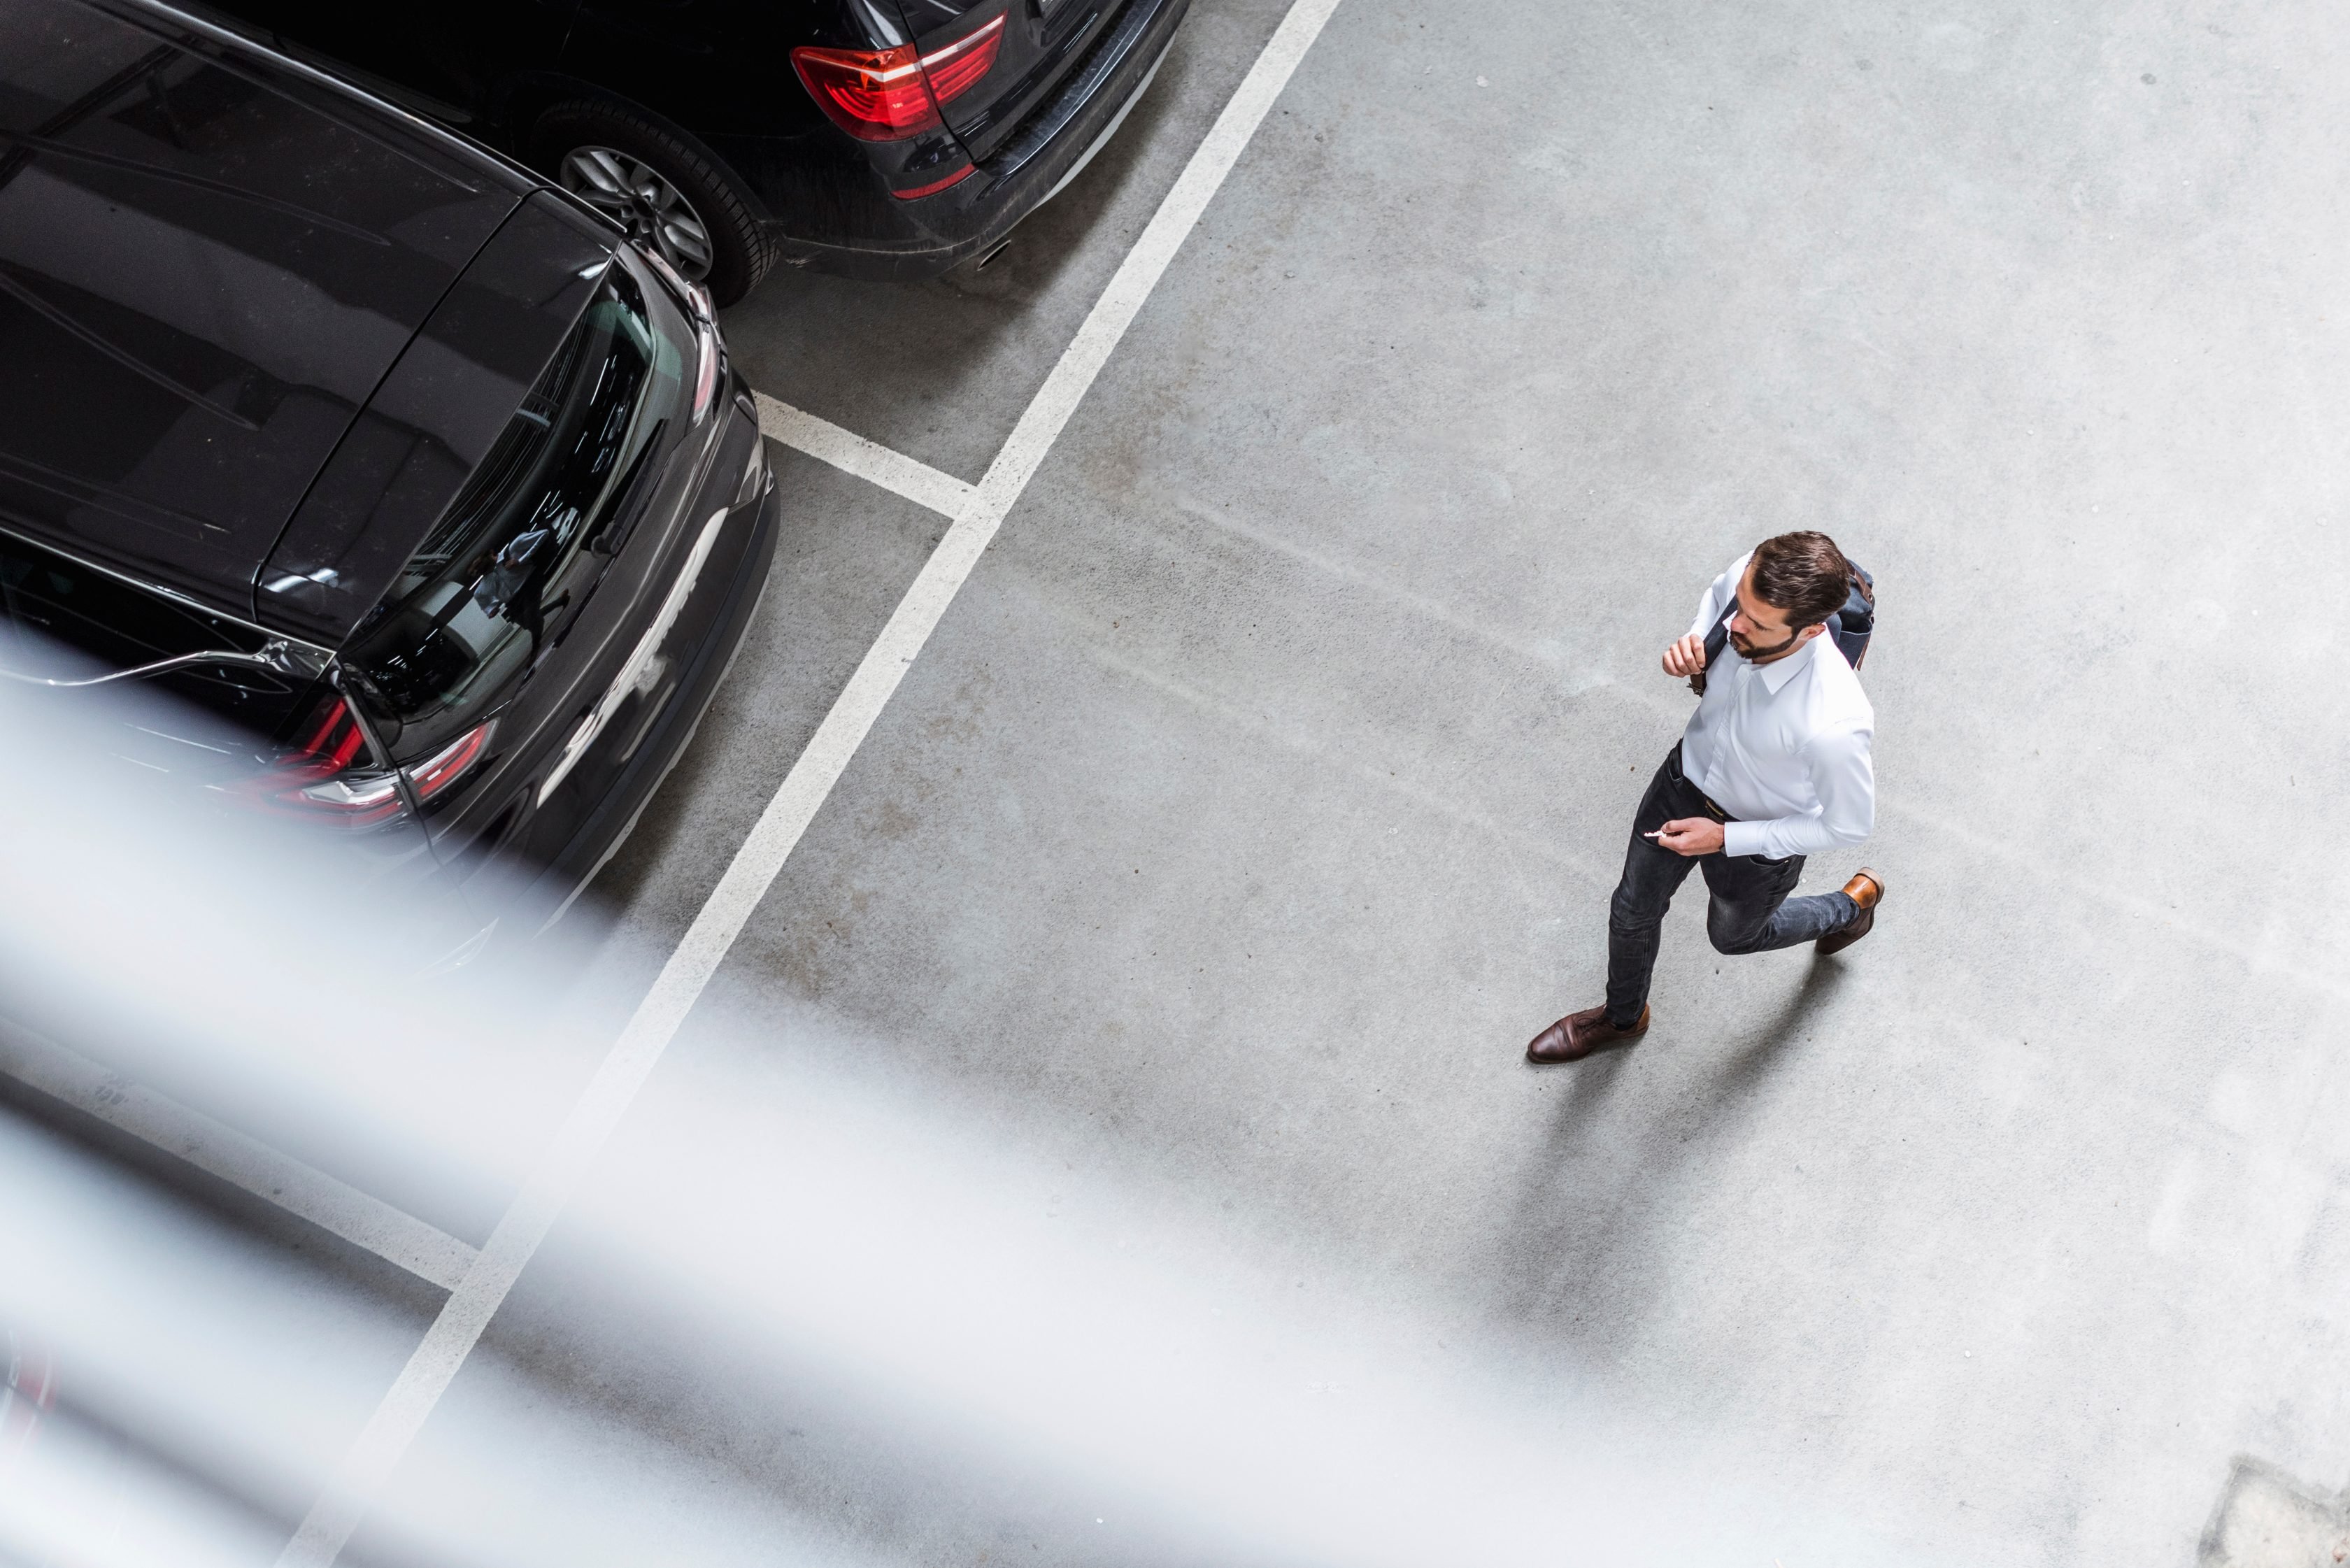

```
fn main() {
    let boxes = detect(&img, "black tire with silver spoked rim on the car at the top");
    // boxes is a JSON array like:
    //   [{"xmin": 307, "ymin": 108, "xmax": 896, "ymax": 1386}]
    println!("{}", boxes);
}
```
[{"xmin": 529, "ymin": 99, "xmax": 776, "ymax": 306}]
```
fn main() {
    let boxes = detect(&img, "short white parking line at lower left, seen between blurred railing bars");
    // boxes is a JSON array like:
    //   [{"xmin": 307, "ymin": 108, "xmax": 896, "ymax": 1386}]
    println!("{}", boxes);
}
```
[{"xmin": 0, "ymin": 1025, "xmax": 475, "ymax": 1290}]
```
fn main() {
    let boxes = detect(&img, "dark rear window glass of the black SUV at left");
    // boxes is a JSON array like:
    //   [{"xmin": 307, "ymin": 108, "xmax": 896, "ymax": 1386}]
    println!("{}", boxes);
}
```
[{"xmin": 346, "ymin": 261, "xmax": 686, "ymax": 762}]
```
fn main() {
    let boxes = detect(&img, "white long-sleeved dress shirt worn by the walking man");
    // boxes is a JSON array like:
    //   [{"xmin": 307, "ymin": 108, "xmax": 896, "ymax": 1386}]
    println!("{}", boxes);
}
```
[{"xmin": 1680, "ymin": 550, "xmax": 1878, "ymax": 860}]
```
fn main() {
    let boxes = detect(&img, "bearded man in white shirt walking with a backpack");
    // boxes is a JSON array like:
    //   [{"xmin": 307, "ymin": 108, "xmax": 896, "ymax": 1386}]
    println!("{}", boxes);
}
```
[{"xmin": 1525, "ymin": 534, "xmax": 1885, "ymax": 1062}]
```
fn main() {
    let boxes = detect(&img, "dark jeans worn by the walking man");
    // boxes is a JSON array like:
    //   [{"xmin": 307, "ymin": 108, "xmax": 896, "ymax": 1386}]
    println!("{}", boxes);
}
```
[{"xmin": 1607, "ymin": 746, "xmax": 1861, "ymax": 1029}]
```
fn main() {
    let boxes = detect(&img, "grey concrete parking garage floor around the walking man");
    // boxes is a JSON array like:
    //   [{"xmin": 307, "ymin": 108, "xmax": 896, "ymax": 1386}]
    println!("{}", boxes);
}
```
[{"xmin": 343, "ymin": 0, "xmax": 2350, "ymax": 1568}]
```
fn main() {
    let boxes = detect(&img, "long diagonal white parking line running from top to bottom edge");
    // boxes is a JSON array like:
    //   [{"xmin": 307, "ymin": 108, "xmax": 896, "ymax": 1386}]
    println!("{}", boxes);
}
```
[{"xmin": 277, "ymin": 0, "xmax": 1339, "ymax": 1568}]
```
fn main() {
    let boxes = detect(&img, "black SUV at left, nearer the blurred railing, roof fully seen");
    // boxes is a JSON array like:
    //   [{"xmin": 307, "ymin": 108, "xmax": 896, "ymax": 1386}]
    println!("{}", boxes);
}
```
[{"xmin": 0, "ymin": 0, "xmax": 778, "ymax": 959}]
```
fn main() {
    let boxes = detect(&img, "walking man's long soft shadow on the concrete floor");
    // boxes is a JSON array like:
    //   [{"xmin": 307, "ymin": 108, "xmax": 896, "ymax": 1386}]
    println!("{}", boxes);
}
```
[{"xmin": 1495, "ymin": 959, "xmax": 1847, "ymax": 1349}]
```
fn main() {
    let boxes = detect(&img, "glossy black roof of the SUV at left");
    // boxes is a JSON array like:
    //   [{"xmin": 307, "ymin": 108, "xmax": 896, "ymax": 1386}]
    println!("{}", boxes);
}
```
[{"xmin": 0, "ymin": 0, "xmax": 534, "ymax": 618}]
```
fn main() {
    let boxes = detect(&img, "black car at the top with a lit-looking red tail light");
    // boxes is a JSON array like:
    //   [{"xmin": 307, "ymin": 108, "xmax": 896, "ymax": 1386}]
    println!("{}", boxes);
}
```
[{"xmin": 190, "ymin": 0, "xmax": 1189, "ymax": 306}]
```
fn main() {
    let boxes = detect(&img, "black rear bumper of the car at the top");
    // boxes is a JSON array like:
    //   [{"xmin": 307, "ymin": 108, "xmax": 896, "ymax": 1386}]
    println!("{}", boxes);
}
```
[{"xmin": 769, "ymin": 0, "xmax": 1192, "ymax": 280}]
